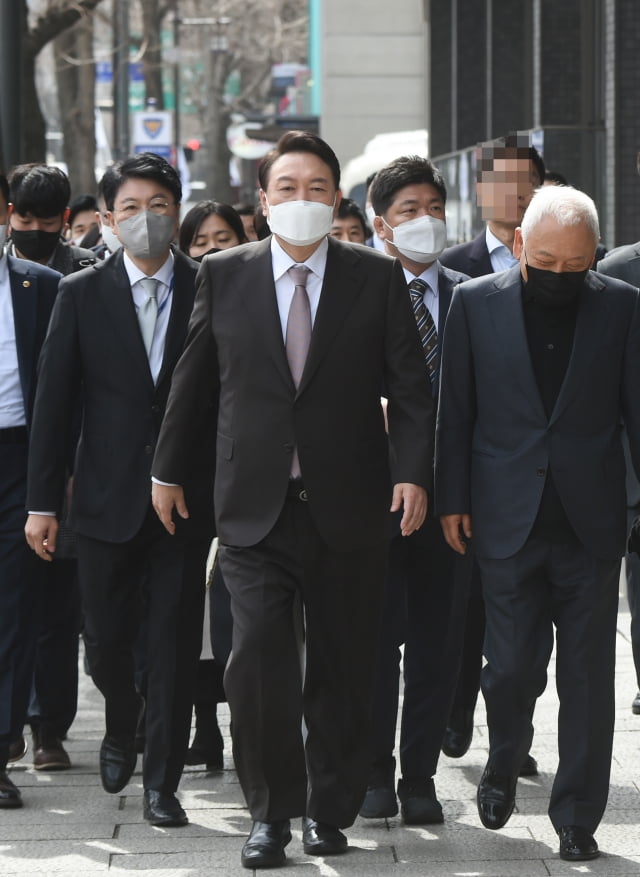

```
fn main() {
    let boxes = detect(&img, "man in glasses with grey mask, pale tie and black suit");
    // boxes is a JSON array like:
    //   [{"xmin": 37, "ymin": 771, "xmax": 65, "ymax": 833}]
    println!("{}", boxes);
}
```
[{"xmin": 26, "ymin": 153, "xmax": 212, "ymax": 825}]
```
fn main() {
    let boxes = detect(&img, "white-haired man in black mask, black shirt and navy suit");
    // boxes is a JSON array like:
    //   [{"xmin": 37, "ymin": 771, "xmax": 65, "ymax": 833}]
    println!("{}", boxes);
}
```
[{"xmin": 436, "ymin": 186, "xmax": 640, "ymax": 861}]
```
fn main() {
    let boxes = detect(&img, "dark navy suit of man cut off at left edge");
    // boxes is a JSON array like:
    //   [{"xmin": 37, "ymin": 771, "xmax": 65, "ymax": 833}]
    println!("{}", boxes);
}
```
[{"xmin": 0, "ymin": 256, "xmax": 60, "ymax": 769}]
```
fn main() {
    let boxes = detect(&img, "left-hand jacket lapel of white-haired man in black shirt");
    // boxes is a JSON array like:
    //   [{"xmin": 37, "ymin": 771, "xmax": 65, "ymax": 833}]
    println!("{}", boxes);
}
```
[{"xmin": 486, "ymin": 265, "xmax": 547, "ymax": 421}]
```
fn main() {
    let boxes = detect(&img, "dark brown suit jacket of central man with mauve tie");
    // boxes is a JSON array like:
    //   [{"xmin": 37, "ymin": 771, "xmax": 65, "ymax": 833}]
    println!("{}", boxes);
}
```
[{"xmin": 153, "ymin": 238, "xmax": 433, "ymax": 551}]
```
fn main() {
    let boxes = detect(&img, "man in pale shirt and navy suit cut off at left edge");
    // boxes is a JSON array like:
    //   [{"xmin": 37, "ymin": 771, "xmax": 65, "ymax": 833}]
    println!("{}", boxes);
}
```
[{"xmin": 0, "ymin": 174, "xmax": 60, "ymax": 808}]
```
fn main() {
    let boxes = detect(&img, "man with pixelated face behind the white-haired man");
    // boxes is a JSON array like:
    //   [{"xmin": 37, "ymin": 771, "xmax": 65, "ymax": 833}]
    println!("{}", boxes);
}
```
[{"xmin": 440, "ymin": 133, "xmax": 545, "ymax": 760}]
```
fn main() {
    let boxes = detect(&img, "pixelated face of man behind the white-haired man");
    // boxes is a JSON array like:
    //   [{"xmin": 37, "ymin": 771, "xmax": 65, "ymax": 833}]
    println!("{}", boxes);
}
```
[{"xmin": 476, "ymin": 157, "xmax": 540, "ymax": 228}]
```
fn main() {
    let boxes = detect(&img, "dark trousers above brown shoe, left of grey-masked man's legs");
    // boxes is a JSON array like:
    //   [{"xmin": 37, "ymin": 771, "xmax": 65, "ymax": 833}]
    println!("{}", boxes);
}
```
[{"xmin": 28, "ymin": 560, "xmax": 80, "ymax": 739}]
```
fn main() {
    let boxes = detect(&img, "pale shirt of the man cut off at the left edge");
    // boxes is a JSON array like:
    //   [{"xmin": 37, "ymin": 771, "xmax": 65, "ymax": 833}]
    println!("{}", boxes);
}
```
[{"xmin": 0, "ymin": 251, "xmax": 27, "ymax": 429}]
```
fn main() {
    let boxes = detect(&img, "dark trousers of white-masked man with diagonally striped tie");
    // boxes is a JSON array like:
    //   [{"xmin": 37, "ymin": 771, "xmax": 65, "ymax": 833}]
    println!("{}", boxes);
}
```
[{"xmin": 373, "ymin": 517, "xmax": 467, "ymax": 779}]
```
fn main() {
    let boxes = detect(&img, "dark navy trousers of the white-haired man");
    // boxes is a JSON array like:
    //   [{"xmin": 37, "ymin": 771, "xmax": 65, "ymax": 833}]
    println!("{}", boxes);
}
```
[{"xmin": 478, "ymin": 538, "xmax": 621, "ymax": 832}]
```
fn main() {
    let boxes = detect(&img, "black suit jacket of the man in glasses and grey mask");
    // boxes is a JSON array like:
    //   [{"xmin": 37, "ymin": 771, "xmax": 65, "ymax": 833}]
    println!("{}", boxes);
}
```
[{"xmin": 27, "ymin": 251, "xmax": 212, "ymax": 542}]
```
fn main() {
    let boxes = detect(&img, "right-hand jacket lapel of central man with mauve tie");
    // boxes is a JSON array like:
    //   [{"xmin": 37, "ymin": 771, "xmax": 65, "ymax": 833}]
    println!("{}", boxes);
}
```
[{"xmin": 298, "ymin": 238, "xmax": 364, "ymax": 395}]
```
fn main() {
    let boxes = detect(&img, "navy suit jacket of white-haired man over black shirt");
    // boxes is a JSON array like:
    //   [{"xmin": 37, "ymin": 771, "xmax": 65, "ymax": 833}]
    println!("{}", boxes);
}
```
[{"xmin": 436, "ymin": 266, "xmax": 640, "ymax": 558}]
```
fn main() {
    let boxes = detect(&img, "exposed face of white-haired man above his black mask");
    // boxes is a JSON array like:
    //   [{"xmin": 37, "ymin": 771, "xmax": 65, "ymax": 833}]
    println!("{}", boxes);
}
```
[{"xmin": 513, "ymin": 216, "xmax": 597, "ymax": 280}]
